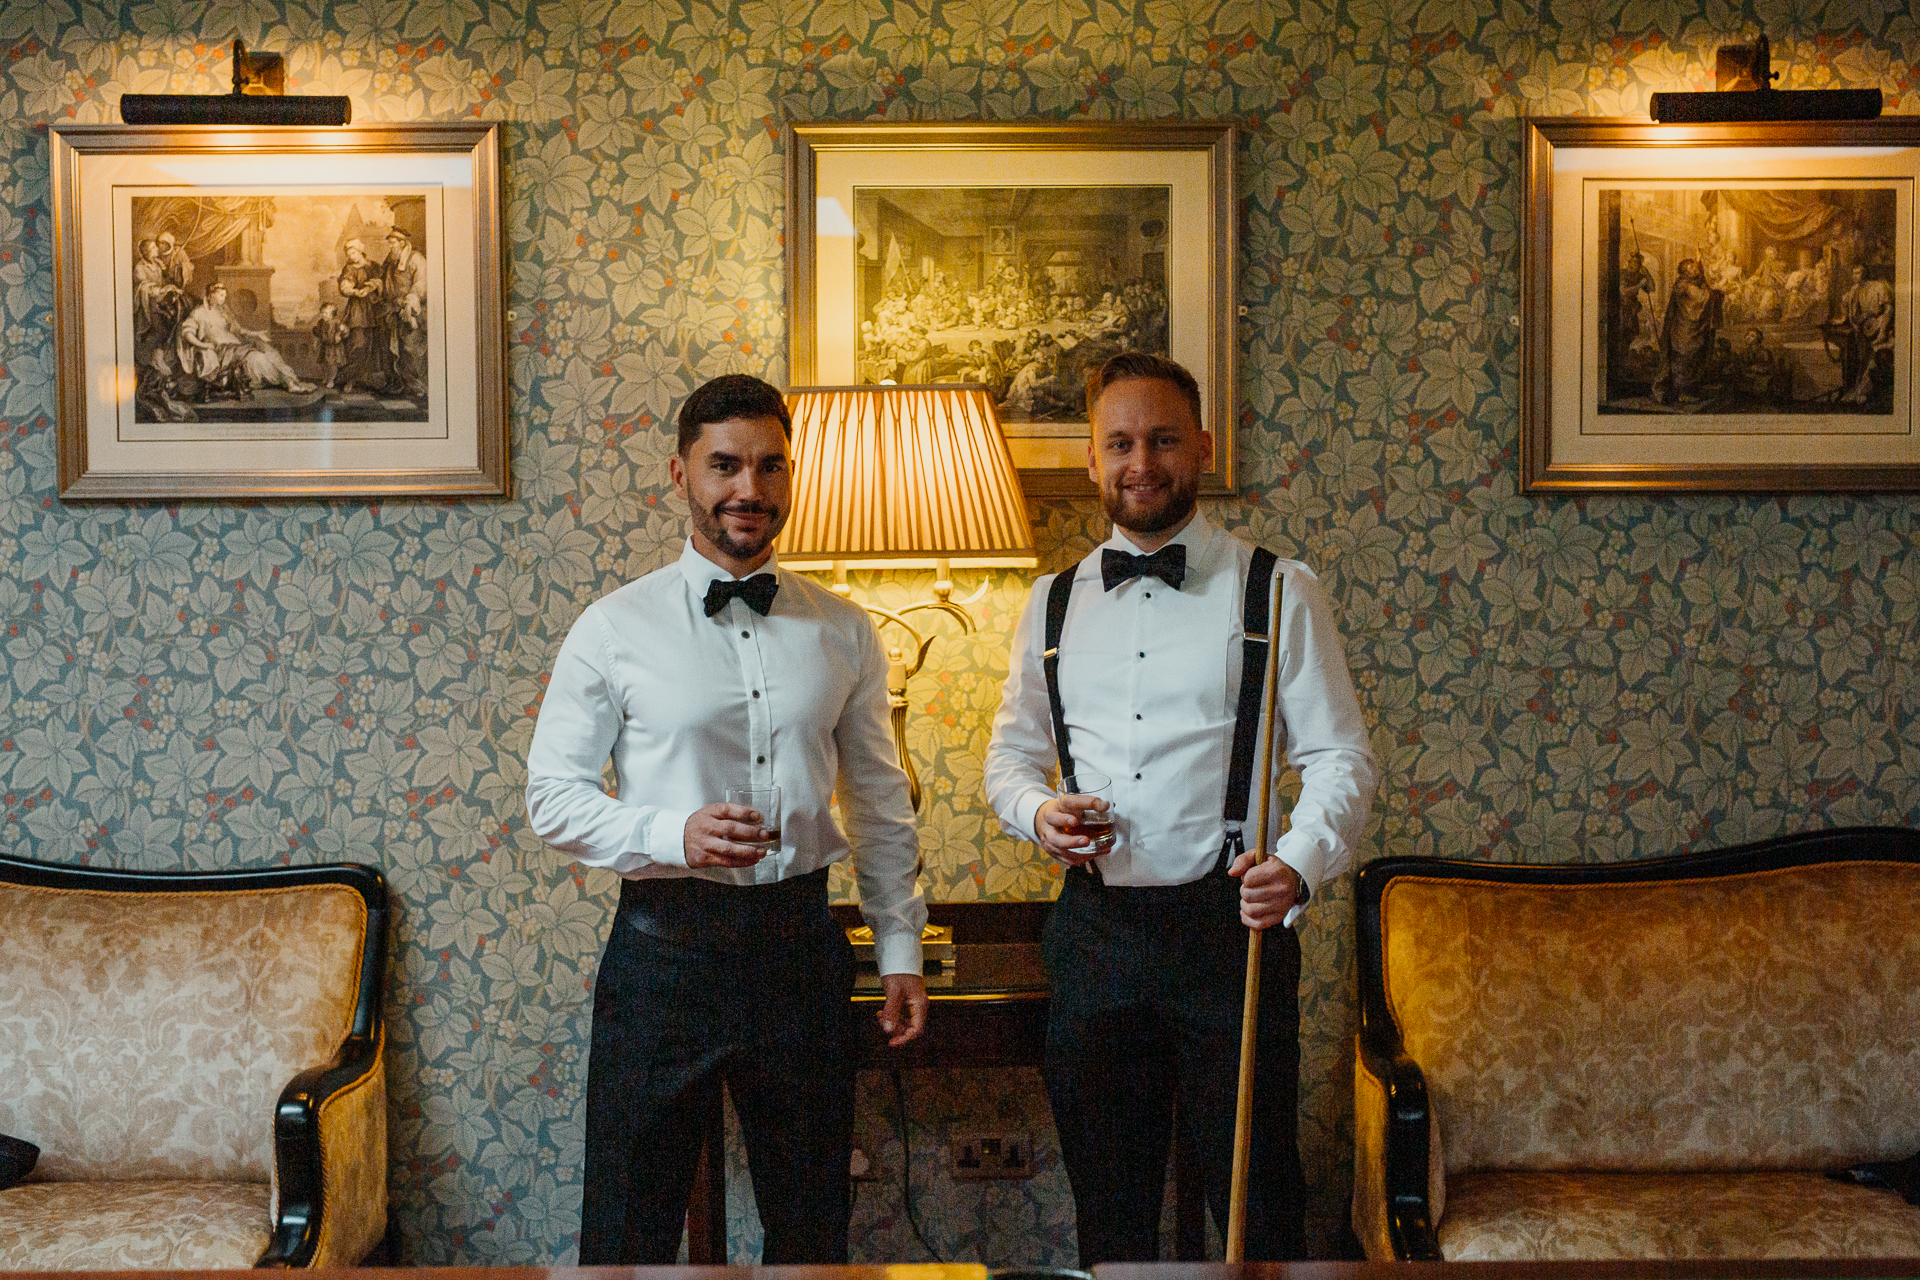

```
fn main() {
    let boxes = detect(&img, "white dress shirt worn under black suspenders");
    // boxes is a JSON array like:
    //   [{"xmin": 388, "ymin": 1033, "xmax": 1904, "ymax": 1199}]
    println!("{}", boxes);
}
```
[{"xmin": 985, "ymin": 514, "xmax": 1379, "ymax": 909}]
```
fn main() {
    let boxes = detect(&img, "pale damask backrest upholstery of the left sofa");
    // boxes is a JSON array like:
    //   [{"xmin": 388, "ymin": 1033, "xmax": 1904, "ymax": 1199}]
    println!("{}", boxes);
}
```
[{"xmin": 0, "ymin": 885, "xmax": 367, "ymax": 1182}]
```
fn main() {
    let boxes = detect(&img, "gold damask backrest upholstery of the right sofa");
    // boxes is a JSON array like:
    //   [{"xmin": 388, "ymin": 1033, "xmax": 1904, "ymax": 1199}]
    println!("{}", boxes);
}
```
[{"xmin": 1380, "ymin": 862, "xmax": 1920, "ymax": 1182}]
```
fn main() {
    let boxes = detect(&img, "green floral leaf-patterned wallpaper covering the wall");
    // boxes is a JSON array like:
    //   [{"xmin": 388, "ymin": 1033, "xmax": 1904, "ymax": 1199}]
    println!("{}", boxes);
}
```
[{"xmin": 0, "ymin": 0, "xmax": 1920, "ymax": 1265}]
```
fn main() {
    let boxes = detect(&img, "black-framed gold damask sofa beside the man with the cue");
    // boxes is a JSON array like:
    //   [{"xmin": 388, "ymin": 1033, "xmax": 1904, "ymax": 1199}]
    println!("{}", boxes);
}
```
[{"xmin": 1354, "ymin": 827, "xmax": 1920, "ymax": 1261}]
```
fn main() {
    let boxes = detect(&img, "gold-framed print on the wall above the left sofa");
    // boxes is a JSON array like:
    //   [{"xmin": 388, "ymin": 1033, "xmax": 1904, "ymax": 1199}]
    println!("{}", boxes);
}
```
[{"xmin": 48, "ymin": 121, "xmax": 509, "ymax": 503}]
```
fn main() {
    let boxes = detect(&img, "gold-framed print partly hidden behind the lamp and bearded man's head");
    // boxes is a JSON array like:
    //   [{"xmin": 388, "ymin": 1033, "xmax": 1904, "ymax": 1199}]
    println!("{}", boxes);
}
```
[{"xmin": 785, "ymin": 121, "xmax": 1240, "ymax": 497}]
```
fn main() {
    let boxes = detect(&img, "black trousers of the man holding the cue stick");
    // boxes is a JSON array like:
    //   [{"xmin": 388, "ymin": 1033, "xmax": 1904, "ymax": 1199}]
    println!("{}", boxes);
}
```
[{"xmin": 1043, "ymin": 855, "xmax": 1306, "ymax": 1267}]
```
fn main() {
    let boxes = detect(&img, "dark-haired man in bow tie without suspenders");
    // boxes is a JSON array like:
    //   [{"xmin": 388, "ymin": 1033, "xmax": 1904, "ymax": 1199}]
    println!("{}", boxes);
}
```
[{"xmin": 526, "ymin": 374, "xmax": 927, "ymax": 1267}]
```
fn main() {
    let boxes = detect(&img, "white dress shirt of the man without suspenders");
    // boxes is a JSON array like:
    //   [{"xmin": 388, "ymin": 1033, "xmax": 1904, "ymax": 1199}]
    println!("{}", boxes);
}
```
[{"xmin": 526, "ymin": 539, "xmax": 927, "ymax": 973}]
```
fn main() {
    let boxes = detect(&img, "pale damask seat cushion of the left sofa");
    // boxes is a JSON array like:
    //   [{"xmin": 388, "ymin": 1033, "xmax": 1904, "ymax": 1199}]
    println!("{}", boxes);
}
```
[{"xmin": 0, "ymin": 1182, "xmax": 273, "ymax": 1270}]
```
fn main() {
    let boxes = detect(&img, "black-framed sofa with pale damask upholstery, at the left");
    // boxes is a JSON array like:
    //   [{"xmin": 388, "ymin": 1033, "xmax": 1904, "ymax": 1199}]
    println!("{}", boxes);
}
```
[{"xmin": 0, "ymin": 858, "xmax": 388, "ymax": 1272}]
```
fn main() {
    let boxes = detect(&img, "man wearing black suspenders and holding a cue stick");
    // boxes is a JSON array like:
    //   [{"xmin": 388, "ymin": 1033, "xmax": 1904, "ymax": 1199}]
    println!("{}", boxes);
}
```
[{"xmin": 985, "ymin": 351, "xmax": 1377, "ymax": 1267}]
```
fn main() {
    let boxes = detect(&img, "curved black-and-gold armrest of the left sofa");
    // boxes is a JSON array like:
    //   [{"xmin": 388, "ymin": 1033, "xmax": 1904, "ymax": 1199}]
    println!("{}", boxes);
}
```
[{"xmin": 255, "ymin": 1029, "xmax": 386, "ymax": 1267}]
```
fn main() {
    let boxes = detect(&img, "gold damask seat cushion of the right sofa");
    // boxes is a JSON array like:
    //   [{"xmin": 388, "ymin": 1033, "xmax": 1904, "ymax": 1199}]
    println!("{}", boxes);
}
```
[{"xmin": 1438, "ymin": 1173, "xmax": 1920, "ymax": 1263}]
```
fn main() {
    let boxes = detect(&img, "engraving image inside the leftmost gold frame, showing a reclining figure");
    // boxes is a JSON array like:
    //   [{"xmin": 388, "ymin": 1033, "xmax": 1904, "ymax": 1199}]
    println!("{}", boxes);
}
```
[{"xmin": 129, "ymin": 190, "xmax": 447, "ymax": 441}]
